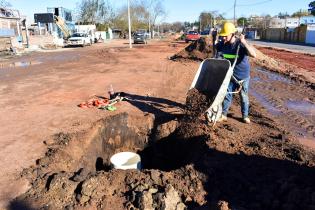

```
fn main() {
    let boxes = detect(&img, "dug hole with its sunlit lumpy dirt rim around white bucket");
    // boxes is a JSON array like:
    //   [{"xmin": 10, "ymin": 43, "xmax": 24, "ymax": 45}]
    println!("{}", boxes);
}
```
[{"xmin": 17, "ymin": 113, "xmax": 212, "ymax": 210}]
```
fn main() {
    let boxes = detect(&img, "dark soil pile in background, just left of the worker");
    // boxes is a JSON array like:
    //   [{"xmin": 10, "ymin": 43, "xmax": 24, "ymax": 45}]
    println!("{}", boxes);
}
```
[{"xmin": 170, "ymin": 37, "xmax": 212, "ymax": 61}]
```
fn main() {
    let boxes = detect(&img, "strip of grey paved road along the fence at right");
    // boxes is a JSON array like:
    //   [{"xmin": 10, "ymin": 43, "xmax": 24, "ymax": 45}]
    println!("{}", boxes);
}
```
[{"xmin": 249, "ymin": 40, "xmax": 315, "ymax": 55}]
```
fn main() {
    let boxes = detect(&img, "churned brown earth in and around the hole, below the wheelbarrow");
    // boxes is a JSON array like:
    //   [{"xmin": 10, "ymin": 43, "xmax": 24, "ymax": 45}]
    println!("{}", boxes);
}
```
[{"xmin": 11, "ymin": 87, "xmax": 315, "ymax": 210}]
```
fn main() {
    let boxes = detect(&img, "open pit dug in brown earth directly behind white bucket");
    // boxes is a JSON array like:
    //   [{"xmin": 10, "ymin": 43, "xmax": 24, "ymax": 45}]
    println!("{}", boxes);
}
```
[{"xmin": 37, "ymin": 113, "xmax": 187, "ymax": 174}]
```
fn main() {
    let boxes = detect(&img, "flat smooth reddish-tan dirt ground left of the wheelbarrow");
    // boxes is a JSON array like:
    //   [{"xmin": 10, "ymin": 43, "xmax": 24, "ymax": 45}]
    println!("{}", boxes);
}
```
[{"xmin": 0, "ymin": 41, "xmax": 198, "ymax": 208}]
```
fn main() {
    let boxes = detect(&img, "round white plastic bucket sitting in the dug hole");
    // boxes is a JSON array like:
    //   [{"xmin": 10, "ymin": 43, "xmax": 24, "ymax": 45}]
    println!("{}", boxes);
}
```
[{"xmin": 110, "ymin": 152, "xmax": 141, "ymax": 170}]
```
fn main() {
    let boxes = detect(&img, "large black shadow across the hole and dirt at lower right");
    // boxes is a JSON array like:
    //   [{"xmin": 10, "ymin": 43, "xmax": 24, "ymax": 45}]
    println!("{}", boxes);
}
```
[{"xmin": 140, "ymin": 126, "xmax": 315, "ymax": 210}]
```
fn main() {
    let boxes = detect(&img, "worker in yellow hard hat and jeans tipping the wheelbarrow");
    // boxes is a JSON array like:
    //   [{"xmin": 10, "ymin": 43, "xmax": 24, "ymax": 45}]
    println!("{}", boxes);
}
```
[{"xmin": 216, "ymin": 22, "xmax": 256, "ymax": 124}]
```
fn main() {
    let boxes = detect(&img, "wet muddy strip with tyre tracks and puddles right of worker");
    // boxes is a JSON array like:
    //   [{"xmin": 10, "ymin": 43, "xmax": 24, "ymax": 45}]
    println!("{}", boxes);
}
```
[{"xmin": 250, "ymin": 68, "xmax": 315, "ymax": 148}]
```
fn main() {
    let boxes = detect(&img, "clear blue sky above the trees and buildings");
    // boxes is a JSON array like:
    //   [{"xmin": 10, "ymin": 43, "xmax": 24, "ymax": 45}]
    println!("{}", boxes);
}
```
[{"xmin": 7, "ymin": 0, "xmax": 312, "ymax": 22}]
